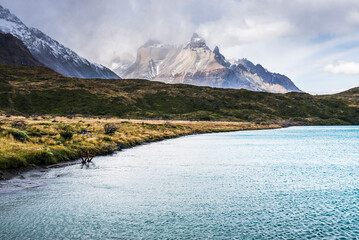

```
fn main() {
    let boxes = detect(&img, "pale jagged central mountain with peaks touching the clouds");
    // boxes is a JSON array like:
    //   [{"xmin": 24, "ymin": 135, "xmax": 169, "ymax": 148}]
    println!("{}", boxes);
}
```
[{"xmin": 115, "ymin": 33, "xmax": 301, "ymax": 93}]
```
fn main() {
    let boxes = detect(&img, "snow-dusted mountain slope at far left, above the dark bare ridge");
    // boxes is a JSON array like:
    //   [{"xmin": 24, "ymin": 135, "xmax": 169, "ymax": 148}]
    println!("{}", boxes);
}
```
[{"xmin": 0, "ymin": 5, "xmax": 119, "ymax": 78}]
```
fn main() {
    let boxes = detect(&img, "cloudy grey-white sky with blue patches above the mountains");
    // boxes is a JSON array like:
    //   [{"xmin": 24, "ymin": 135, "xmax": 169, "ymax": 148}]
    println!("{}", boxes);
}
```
[{"xmin": 0, "ymin": 0, "xmax": 359, "ymax": 94}]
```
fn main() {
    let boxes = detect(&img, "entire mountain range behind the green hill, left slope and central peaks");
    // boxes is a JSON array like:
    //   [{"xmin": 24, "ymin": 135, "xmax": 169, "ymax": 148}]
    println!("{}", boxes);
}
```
[{"xmin": 0, "ymin": 6, "xmax": 301, "ymax": 93}]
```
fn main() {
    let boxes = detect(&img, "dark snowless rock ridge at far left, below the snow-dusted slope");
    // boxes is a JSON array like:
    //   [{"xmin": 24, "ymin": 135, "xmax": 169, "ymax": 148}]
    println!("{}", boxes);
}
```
[{"xmin": 0, "ymin": 33, "xmax": 43, "ymax": 66}]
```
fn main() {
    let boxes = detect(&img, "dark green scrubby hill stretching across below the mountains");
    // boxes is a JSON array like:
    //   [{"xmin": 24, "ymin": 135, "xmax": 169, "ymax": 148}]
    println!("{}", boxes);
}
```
[{"xmin": 0, "ymin": 65, "xmax": 359, "ymax": 124}]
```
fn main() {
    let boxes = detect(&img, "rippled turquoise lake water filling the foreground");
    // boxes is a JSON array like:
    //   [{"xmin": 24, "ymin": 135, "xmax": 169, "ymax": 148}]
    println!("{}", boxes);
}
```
[{"xmin": 0, "ymin": 126, "xmax": 359, "ymax": 239}]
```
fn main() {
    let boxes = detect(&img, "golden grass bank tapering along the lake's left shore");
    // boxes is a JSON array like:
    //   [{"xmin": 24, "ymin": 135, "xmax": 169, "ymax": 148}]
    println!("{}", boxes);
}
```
[{"xmin": 0, "ymin": 116, "xmax": 281, "ymax": 173}]
